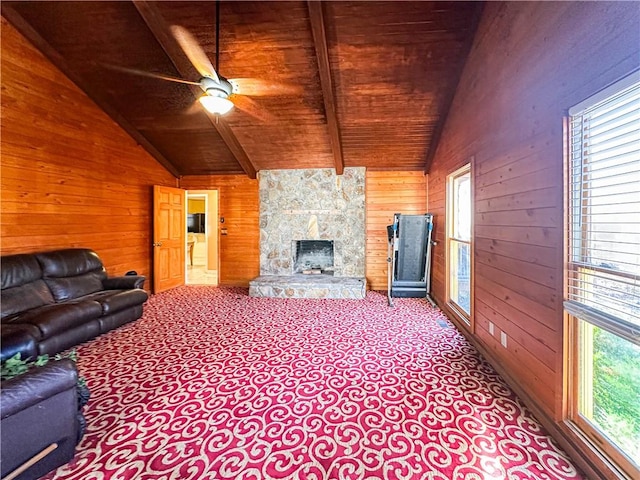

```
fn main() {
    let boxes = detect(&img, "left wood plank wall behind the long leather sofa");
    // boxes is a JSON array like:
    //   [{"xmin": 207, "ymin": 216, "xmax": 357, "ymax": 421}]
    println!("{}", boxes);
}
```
[{"xmin": 0, "ymin": 18, "xmax": 177, "ymax": 275}]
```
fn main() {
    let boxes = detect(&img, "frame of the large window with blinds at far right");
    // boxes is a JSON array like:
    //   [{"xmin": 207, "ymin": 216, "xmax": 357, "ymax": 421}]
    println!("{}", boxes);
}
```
[{"xmin": 563, "ymin": 71, "xmax": 640, "ymax": 478}]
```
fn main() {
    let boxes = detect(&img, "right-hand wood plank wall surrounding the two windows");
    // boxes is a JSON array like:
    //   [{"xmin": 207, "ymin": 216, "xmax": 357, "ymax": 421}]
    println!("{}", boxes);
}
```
[{"xmin": 429, "ymin": 2, "xmax": 640, "ymax": 470}]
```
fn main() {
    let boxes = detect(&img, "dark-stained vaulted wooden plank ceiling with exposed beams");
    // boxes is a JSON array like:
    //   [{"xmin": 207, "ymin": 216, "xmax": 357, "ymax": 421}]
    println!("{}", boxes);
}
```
[{"xmin": 2, "ymin": 1, "xmax": 482, "ymax": 178}]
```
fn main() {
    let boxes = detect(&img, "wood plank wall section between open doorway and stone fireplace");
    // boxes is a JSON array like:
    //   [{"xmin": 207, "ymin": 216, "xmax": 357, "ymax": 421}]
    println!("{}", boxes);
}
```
[{"xmin": 180, "ymin": 175, "xmax": 260, "ymax": 287}]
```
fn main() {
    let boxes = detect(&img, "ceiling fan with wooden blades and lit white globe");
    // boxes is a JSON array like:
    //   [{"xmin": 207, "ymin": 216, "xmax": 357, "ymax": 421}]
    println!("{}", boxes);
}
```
[{"xmin": 105, "ymin": 0, "xmax": 299, "ymax": 120}]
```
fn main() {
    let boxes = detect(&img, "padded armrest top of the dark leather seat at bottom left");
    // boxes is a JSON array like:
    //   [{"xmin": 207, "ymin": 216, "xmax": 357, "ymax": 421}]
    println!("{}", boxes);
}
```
[{"xmin": 0, "ymin": 358, "xmax": 78, "ymax": 419}]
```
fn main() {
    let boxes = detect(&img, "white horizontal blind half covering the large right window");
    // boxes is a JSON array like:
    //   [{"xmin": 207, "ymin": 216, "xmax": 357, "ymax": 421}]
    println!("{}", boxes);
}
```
[{"xmin": 565, "ymin": 74, "xmax": 640, "ymax": 344}]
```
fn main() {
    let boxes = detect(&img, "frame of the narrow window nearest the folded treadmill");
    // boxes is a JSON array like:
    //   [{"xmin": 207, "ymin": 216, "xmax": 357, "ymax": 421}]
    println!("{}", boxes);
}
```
[{"xmin": 445, "ymin": 161, "xmax": 474, "ymax": 331}]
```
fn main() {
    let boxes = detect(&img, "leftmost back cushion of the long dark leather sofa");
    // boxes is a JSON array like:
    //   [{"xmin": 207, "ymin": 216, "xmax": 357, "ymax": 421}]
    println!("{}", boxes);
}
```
[{"xmin": 0, "ymin": 255, "xmax": 54, "ymax": 318}]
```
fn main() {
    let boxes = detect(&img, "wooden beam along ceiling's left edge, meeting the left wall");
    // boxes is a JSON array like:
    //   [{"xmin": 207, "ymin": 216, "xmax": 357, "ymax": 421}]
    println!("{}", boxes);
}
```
[{"xmin": 2, "ymin": 3, "xmax": 180, "ymax": 178}]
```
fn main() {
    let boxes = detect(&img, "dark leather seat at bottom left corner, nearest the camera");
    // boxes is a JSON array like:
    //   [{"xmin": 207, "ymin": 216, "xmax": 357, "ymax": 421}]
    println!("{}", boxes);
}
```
[{"xmin": 0, "ymin": 359, "xmax": 82, "ymax": 480}]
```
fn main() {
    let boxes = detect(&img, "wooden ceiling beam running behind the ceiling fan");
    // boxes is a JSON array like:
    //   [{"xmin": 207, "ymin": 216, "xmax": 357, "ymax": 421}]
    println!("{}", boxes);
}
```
[{"xmin": 133, "ymin": 0, "xmax": 256, "ymax": 179}]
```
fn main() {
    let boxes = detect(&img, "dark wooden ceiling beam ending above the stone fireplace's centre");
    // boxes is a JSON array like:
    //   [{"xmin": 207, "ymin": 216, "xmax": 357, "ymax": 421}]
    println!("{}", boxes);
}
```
[{"xmin": 307, "ymin": 0, "xmax": 344, "ymax": 175}]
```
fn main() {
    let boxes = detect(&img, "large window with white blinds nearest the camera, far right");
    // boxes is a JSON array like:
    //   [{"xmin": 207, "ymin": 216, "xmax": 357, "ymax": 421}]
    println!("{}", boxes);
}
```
[{"xmin": 564, "ymin": 72, "xmax": 640, "ymax": 477}]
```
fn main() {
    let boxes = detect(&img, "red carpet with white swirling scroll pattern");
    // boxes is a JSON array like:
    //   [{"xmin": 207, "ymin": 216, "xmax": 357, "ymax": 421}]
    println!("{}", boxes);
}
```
[{"xmin": 46, "ymin": 287, "xmax": 582, "ymax": 480}]
